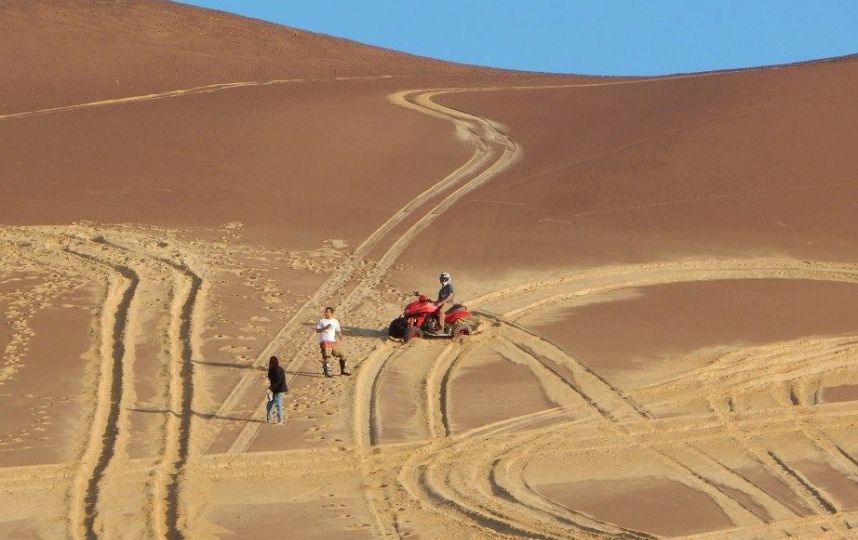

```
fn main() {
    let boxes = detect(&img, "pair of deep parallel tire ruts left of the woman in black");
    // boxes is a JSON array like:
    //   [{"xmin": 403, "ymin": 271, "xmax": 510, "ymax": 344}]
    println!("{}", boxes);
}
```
[{"xmin": 2, "ymin": 227, "xmax": 213, "ymax": 538}]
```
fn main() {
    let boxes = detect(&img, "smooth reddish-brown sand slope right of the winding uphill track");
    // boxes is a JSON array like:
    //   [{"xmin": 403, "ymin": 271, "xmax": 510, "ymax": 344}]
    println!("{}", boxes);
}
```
[{"xmin": 398, "ymin": 57, "xmax": 858, "ymax": 269}]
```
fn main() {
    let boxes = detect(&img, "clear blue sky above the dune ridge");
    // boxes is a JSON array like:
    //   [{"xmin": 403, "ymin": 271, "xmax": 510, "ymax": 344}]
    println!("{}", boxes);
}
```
[{"xmin": 179, "ymin": 0, "xmax": 858, "ymax": 75}]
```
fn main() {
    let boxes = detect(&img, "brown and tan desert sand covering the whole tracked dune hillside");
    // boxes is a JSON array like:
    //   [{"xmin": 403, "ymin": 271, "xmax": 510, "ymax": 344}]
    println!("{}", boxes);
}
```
[{"xmin": 0, "ymin": 0, "xmax": 858, "ymax": 539}]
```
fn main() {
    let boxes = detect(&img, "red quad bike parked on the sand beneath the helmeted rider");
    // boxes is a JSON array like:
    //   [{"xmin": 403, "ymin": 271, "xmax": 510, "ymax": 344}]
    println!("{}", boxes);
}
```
[{"xmin": 387, "ymin": 291, "xmax": 479, "ymax": 342}]
